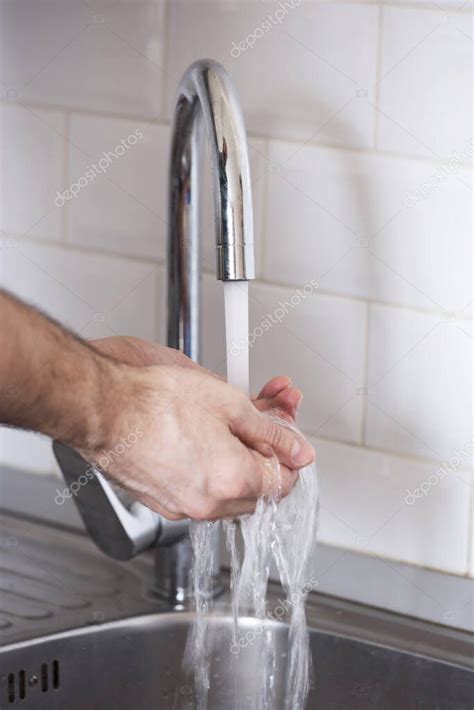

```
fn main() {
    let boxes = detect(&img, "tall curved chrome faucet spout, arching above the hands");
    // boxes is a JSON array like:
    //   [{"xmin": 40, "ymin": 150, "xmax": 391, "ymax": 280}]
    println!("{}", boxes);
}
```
[{"xmin": 168, "ymin": 59, "xmax": 255, "ymax": 361}]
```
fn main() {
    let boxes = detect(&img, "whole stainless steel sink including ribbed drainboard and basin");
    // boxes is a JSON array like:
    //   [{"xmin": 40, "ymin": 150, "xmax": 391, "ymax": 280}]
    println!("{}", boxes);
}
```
[{"xmin": 0, "ymin": 518, "xmax": 474, "ymax": 710}]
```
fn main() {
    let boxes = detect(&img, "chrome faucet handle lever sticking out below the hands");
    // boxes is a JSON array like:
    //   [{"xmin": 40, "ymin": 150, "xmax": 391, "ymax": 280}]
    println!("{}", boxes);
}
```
[{"xmin": 53, "ymin": 441, "xmax": 188, "ymax": 560}]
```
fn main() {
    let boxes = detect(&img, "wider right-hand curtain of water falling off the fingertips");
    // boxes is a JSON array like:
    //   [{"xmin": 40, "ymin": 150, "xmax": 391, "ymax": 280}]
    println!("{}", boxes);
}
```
[{"xmin": 231, "ymin": 420, "xmax": 319, "ymax": 710}]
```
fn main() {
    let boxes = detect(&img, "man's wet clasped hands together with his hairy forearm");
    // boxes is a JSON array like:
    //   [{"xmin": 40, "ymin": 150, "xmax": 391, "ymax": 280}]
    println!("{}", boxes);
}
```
[{"xmin": 0, "ymin": 290, "xmax": 314, "ymax": 519}]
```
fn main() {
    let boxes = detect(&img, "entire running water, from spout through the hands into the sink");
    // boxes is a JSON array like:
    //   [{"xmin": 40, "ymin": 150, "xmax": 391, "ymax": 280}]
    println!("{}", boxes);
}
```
[{"xmin": 184, "ymin": 281, "xmax": 319, "ymax": 710}]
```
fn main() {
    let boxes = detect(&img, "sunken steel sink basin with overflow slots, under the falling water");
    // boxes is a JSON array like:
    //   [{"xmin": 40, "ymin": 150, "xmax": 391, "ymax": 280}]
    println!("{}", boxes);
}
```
[{"xmin": 0, "ymin": 612, "xmax": 474, "ymax": 710}]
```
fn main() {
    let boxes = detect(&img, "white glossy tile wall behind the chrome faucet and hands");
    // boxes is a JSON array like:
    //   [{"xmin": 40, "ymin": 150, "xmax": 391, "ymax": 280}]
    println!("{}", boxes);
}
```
[{"xmin": 0, "ymin": 0, "xmax": 474, "ymax": 583}]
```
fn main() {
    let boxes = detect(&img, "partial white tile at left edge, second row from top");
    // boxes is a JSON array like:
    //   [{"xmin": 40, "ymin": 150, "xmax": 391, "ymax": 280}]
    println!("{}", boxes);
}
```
[{"xmin": 0, "ymin": 103, "xmax": 65, "ymax": 239}]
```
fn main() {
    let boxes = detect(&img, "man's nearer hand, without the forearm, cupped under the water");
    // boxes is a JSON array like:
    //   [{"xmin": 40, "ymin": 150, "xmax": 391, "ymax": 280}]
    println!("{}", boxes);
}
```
[{"xmin": 80, "ymin": 362, "xmax": 314, "ymax": 520}]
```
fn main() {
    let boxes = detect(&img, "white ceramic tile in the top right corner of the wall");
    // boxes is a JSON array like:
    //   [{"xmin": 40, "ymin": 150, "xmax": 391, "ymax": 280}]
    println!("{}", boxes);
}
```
[{"xmin": 377, "ymin": 7, "xmax": 474, "ymax": 157}]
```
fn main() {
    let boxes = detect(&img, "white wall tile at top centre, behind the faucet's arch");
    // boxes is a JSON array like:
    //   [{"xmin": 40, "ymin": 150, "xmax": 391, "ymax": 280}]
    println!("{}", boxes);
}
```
[{"xmin": 165, "ymin": 0, "xmax": 377, "ymax": 146}]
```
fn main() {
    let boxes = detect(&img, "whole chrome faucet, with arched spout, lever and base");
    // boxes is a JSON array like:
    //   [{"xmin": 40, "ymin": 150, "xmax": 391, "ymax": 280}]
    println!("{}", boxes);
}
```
[{"xmin": 53, "ymin": 59, "xmax": 255, "ymax": 605}]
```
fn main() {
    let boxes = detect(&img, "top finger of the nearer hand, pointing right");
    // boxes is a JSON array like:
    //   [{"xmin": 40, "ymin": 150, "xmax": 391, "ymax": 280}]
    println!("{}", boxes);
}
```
[{"xmin": 231, "ymin": 404, "xmax": 314, "ymax": 469}]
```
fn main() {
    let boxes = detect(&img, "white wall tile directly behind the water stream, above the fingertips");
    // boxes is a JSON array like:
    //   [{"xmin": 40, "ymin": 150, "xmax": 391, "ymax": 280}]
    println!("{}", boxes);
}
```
[{"xmin": 203, "ymin": 279, "xmax": 365, "ymax": 441}]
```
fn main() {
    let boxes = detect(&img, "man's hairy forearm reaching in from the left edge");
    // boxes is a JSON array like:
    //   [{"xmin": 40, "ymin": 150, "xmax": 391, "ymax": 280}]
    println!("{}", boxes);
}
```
[{"xmin": 0, "ymin": 291, "xmax": 117, "ymax": 449}]
